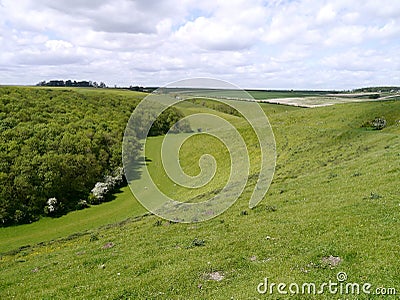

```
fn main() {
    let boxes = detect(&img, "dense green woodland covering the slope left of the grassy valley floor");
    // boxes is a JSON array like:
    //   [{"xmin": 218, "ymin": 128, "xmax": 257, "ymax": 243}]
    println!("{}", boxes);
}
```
[{"xmin": 0, "ymin": 87, "xmax": 141, "ymax": 226}]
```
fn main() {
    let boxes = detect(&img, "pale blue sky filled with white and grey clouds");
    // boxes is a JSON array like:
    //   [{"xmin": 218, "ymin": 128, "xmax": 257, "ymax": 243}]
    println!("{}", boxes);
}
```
[{"xmin": 0, "ymin": 0, "xmax": 400, "ymax": 89}]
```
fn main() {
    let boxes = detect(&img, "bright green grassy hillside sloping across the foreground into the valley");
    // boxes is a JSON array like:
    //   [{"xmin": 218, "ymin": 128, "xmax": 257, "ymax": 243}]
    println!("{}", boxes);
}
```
[{"xmin": 0, "ymin": 88, "xmax": 400, "ymax": 299}]
